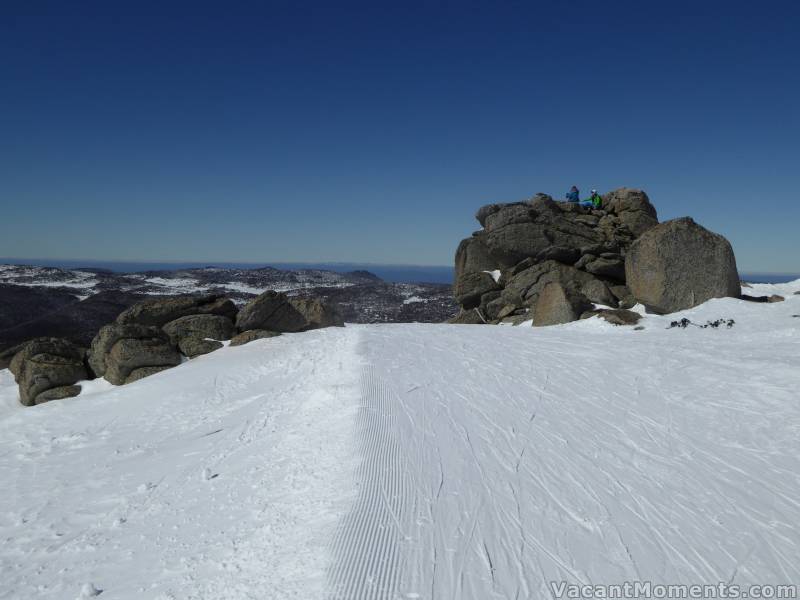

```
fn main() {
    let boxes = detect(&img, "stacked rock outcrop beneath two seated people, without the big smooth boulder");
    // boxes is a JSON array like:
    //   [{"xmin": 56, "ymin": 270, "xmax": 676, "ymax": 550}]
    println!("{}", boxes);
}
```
[{"xmin": 452, "ymin": 188, "xmax": 658, "ymax": 323}]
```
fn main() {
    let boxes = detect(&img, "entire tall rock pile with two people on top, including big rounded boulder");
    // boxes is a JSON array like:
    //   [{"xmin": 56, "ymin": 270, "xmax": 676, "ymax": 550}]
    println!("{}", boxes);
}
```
[{"xmin": 451, "ymin": 188, "xmax": 740, "ymax": 325}]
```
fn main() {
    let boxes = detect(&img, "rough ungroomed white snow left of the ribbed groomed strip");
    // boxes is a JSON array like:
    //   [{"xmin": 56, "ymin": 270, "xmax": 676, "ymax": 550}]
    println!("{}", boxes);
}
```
[{"xmin": 0, "ymin": 328, "xmax": 358, "ymax": 600}]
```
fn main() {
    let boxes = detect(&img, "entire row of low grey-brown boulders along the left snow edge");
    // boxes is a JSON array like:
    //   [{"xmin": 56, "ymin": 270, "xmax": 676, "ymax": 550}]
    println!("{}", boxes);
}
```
[{"xmin": 6, "ymin": 291, "xmax": 344, "ymax": 406}]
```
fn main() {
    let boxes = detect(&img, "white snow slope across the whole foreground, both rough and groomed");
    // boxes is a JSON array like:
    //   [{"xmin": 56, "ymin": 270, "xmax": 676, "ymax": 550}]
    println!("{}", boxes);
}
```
[{"xmin": 0, "ymin": 282, "xmax": 800, "ymax": 600}]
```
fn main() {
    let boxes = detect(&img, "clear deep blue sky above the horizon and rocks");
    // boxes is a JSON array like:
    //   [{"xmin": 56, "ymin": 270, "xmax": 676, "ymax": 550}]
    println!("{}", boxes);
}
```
[{"xmin": 0, "ymin": 1, "xmax": 800, "ymax": 272}]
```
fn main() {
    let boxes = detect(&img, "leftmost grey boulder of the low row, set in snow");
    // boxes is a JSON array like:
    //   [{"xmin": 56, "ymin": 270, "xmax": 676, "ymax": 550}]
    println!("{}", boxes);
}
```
[{"xmin": 9, "ymin": 338, "xmax": 88, "ymax": 406}]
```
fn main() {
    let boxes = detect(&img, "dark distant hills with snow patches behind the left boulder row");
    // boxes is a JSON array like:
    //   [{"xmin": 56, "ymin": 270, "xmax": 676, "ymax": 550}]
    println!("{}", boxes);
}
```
[{"xmin": 0, "ymin": 265, "xmax": 457, "ymax": 351}]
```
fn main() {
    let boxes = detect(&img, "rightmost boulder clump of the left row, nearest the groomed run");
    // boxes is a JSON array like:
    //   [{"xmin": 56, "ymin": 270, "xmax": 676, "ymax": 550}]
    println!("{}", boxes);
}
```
[{"xmin": 236, "ymin": 291, "xmax": 344, "ymax": 333}]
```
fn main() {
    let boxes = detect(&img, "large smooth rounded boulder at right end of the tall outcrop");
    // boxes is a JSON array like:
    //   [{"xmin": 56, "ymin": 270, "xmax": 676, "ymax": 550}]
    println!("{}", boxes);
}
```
[{"xmin": 625, "ymin": 217, "xmax": 742, "ymax": 314}]
